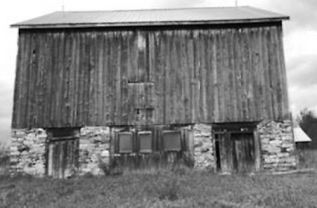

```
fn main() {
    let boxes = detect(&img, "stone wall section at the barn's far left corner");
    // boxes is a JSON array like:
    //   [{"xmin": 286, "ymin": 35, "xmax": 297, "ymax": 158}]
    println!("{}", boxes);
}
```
[{"xmin": 10, "ymin": 129, "xmax": 47, "ymax": 176}]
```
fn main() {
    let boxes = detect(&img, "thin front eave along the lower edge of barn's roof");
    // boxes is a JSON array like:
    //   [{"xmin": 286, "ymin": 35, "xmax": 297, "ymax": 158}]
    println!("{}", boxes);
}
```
[{"xmin": 10, "ymin": 16, "xmax": 290, "ymax": 29}]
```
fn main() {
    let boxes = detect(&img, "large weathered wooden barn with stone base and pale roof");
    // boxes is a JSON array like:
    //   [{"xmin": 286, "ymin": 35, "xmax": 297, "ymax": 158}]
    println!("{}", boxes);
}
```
[{"xmin": 11, "ymin": 7, "xmax": 296, "ymax": 177}]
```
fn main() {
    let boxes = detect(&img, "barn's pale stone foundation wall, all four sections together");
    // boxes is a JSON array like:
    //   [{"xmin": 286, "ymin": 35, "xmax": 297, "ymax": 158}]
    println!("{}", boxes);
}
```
[{"xmin": 10, "ymin": 121, "xmax": 297, "ymax": 176}]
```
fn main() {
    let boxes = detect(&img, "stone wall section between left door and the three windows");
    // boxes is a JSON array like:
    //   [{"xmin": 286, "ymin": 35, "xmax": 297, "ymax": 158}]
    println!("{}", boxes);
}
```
[{"xmin": 79, "ymin": 127, "xmax": 110, "ymax": 175}]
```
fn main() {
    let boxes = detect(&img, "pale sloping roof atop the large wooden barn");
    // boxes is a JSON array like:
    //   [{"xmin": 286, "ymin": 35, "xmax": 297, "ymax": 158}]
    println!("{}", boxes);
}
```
[{"xmin": 11, "ymin": 6, "xmax": 289, "ymax": 28}]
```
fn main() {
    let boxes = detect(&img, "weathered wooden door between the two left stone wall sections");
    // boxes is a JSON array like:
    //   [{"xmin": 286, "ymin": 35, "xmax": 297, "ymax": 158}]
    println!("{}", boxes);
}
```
[{"xmin": 47, "ymin": 138, "xmax": 79, "ymax": 178}]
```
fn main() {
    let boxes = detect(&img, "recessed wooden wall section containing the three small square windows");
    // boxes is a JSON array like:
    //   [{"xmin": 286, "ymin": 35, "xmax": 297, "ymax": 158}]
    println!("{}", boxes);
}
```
[{"xmin": 111, "ymin": 126, "xmax": 193, "ymax": 170}]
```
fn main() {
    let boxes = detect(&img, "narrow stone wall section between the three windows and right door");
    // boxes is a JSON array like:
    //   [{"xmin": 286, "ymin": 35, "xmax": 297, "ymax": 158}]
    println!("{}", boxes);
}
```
[{"xmin": 193, "ymin": 124, "xmax": 216, "ymax": 170}]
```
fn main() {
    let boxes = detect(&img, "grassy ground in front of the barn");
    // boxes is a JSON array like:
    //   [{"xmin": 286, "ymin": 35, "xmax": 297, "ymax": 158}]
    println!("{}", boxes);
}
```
[{"xmin": 0, "ymin": 169, "xmax": 317, "ymax": 208}]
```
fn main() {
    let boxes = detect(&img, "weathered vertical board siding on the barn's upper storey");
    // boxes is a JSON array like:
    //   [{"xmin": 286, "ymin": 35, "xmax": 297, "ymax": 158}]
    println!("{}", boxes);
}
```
[{"xmin": 12, "ymin": 25, "xmax": 288, "ymax": 128}]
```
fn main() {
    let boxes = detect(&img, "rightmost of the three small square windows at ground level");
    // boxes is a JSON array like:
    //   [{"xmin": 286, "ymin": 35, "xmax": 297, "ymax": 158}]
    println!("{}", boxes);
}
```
[{"xmin": 163, "ymin": 131, "xmax": 181, "ymax": 151}]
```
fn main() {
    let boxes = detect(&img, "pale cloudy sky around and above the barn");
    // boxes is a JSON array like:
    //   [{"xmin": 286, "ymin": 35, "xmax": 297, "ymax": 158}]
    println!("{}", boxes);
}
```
[{"xmin": 0, "ymin": 0, "xmax": 317, "ymax": 141}]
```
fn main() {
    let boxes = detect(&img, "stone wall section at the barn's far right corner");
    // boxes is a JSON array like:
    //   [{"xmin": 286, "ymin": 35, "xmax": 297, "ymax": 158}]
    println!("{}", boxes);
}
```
[{"xmin": 258, "ymin": 121, "xmax": 297, "ymax": 172}]
